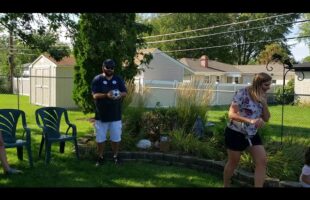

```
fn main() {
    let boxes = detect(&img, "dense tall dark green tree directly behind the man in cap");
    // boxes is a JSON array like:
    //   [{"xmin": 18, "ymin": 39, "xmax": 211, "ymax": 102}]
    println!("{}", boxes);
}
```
[{"xmin": 73, "ymin": 13, "xmax": 151, "ymax": 113}]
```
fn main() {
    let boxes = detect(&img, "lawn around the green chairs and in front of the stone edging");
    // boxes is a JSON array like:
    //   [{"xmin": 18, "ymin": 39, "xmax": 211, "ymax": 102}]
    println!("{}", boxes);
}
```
[{"xmin": 0, "ymin": 95, "xmax": 223, "ymax": 187}]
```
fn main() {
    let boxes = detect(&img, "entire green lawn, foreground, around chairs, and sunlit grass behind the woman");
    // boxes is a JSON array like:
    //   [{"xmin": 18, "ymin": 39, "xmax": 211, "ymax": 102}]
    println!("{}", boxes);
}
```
[{"xmin": 0, "ymin": 95, "xmax": 310, "ymax": 187}]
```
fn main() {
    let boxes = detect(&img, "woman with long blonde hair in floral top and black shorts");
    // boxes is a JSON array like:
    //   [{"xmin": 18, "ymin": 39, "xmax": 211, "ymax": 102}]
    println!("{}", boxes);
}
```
[{"xmin": 224, "ymin": 73, "xmax": 272, "ymax": 187}]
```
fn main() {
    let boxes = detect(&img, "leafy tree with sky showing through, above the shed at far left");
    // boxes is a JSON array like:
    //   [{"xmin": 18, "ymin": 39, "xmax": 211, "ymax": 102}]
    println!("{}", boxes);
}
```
[{"xmin": 0, "ymin": 13, "xmax": 76, "ymax": 91}]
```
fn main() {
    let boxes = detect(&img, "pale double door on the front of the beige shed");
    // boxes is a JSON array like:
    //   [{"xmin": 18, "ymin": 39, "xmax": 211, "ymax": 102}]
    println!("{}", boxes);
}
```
[{"xmin": 35, "ymin": 68, "xmax": 51, "ymax": 106}]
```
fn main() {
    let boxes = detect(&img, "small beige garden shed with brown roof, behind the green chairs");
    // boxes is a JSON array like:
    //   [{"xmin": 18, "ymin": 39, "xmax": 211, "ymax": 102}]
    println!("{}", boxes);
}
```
[{"xmin": 29, "ymin": 55, "xmax": 77, "ymax": 108}]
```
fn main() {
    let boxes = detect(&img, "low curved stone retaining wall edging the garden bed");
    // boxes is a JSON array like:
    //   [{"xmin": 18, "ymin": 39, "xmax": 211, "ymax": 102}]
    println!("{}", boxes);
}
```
[{"xmin": 79, "ymin": 145, "xmax": 301, "ymax": 187}]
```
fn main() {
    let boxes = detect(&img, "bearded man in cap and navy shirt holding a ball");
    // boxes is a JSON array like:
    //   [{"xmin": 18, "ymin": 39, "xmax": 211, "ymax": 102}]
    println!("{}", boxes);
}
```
[{"xmin": 91, "ymin": 59, "xmax": 127, "ymax": 166}]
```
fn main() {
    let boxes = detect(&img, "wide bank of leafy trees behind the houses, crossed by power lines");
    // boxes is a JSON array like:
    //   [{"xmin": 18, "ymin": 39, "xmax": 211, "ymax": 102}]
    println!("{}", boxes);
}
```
[{"xmin": 146, "ymin": 13, "xmax": 299, "ymax": 65}]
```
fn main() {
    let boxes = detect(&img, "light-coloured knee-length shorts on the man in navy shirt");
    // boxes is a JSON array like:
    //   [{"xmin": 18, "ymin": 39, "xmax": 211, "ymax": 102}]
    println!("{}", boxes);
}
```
[{"xmin": 95, "ymin": 120, "xmax": 122, "ymax": 143}]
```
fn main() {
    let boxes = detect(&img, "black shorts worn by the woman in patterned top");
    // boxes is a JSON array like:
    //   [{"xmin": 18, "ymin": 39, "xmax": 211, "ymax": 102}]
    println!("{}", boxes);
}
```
[{"xmin": 225, "ymin": 127, "xmax": 263, "ymax": 151}]
